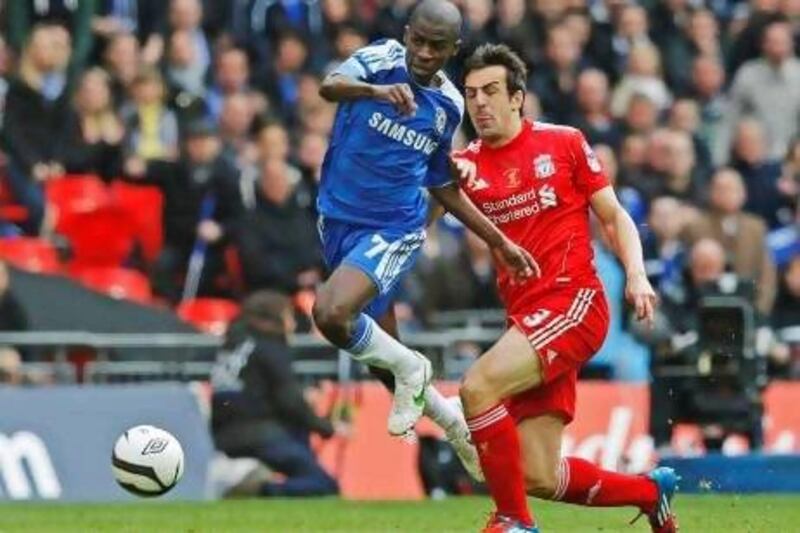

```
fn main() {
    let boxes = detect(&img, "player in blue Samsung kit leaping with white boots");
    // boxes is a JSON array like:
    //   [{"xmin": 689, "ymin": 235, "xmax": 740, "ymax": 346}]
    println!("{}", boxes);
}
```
[{"xmin": 313, "ymin": 0, "xmax": 537, "ymax": 478}]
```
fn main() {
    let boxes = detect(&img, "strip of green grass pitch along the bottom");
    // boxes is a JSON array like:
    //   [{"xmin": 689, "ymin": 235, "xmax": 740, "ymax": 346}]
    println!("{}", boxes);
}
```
[{"xmin": 0, "ymin": 495, "xmax": 800, "ymax": 533}]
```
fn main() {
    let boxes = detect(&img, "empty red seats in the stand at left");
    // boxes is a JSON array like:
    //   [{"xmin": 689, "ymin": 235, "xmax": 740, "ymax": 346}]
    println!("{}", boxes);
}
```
[{"xmin": 0, "ymin": 175, "xmax": 244, "ymax": 335}]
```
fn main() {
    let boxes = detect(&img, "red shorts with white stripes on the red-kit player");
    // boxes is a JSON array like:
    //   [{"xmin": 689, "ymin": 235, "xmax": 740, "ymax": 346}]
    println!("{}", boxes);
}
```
[{"xmin": 508, "ymin": 287, "xmax": 609, "ymax": 424}]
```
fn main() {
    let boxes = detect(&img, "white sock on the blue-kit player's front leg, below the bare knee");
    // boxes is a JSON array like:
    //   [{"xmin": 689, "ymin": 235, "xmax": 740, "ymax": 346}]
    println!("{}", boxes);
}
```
[{"xmin": 347, "ymin": 315, "xmax": 419, "ymax": 375}]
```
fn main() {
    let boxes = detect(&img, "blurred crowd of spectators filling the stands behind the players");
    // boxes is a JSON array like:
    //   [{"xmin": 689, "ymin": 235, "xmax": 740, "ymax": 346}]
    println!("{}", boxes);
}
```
[{"xmin": 0, "ymin": 0, "xmax": 800, "ymax": 378}]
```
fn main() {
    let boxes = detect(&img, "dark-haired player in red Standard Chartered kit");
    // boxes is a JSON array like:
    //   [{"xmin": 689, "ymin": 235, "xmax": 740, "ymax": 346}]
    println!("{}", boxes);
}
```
[{"xmin": 453, "ymin": 44, "xmax": 678, "ymax": 533}]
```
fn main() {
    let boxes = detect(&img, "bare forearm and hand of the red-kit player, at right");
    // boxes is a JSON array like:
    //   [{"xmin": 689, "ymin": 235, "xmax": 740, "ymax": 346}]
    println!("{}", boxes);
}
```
[{"xmin": 591, "ymin": 185, "xmax": 658, "ymax": 324}]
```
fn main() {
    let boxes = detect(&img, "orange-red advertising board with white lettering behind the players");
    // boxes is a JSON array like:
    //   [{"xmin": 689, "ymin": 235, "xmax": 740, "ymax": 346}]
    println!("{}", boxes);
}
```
[{"xmin": 319, "ymin": 382, "xmax": 800, "ymax": 499}]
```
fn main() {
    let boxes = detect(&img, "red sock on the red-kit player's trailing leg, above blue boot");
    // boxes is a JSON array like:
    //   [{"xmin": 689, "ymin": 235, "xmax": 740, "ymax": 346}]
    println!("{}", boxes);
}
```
[{"xmin": 553, "ymin": 457, "xmax": 658, "ymax": 512}]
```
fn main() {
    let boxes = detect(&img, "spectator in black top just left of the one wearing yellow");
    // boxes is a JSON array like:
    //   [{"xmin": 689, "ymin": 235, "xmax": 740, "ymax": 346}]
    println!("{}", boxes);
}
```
[{"xmin": 63, "ymin": 67, "xmax": 125, "ymax": 182}]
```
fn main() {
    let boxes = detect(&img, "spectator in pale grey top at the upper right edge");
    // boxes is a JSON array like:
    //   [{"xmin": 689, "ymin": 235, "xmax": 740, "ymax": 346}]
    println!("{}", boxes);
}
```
[{"xmin": 726, "ymin": 21, "xmax": 800, "ymax": 159}]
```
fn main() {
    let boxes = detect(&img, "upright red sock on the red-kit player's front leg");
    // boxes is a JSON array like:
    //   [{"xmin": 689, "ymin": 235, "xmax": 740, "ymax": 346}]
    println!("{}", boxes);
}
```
[{"xmin": 467, "ymin": 404, "xmax": 533, "ymax": 525}]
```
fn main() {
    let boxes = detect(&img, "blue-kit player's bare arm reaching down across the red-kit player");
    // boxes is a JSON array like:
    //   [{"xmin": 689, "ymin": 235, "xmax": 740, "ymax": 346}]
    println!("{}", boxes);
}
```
[{"xmin": 429, "ymin": 183, "xmax": 541, "ymax": 278}]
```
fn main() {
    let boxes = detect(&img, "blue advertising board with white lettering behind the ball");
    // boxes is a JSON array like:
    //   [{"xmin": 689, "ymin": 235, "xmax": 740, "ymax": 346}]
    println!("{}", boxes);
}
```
[{"xmin": 0, "ymin": 385, "xmax": 212, "ymax": 501}]
